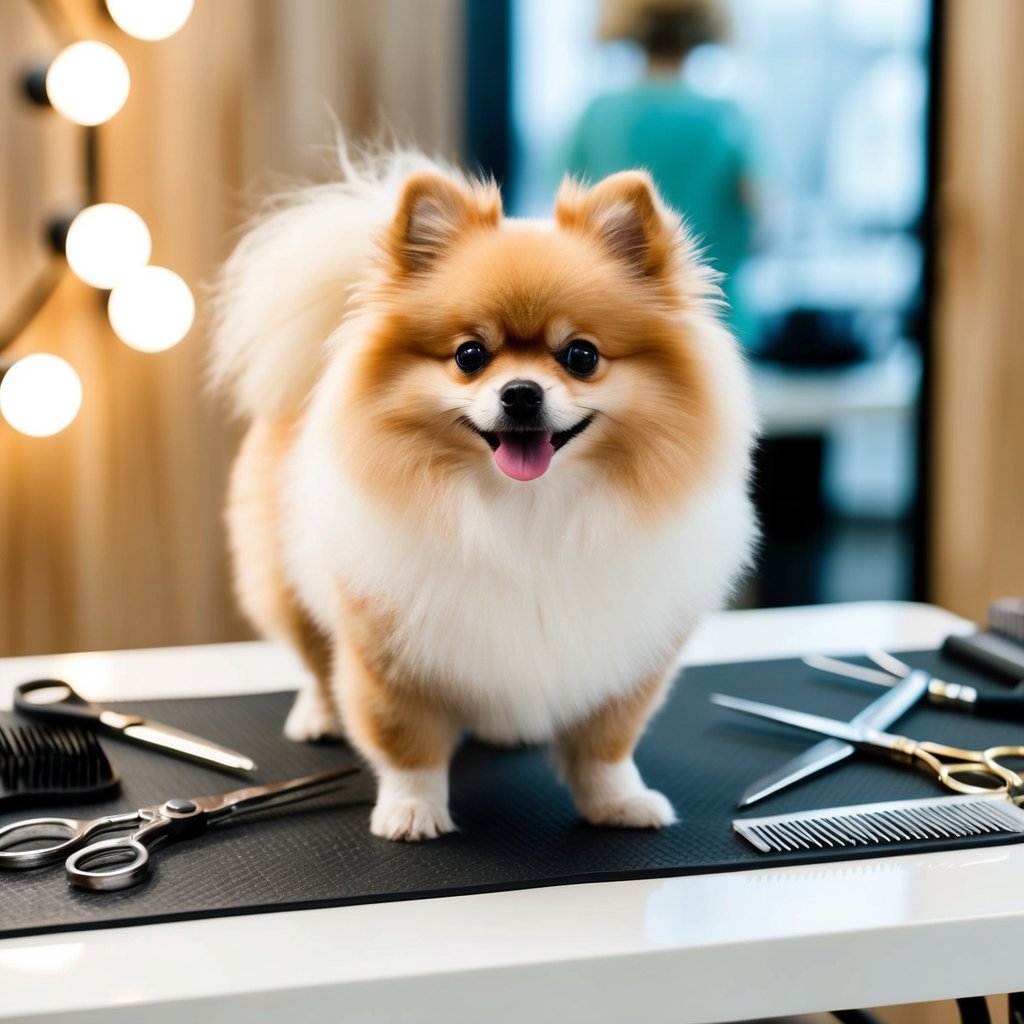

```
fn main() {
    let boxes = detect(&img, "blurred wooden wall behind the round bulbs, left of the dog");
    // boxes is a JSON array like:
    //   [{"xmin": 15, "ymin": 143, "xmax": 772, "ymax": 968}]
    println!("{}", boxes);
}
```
[{"xmin": 0, "ymin": 0, "xmax": 462, "ymax": 655}]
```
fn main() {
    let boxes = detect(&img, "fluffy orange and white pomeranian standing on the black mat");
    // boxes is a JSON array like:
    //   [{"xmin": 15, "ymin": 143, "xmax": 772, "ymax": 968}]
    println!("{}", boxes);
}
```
[{"xmin": 212, "ymin": 152, "xmax": 757, "ymax": 840}]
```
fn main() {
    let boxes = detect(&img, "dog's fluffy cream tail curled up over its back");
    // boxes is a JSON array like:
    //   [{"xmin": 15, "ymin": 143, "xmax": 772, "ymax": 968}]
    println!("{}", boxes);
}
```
[{"xmin": 209, "ymin": 147, "xmax": 451, "ymax": 419}]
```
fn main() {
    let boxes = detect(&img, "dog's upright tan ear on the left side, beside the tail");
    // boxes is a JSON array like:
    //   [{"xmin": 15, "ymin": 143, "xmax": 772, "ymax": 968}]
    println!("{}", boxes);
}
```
[{"xmin": 387, "ymin": 172, "xmax": 502, "ymax": 273}]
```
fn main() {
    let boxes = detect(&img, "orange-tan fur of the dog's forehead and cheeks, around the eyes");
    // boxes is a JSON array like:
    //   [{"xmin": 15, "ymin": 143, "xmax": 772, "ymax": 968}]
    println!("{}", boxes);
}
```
[{"xmin": 337, "ymin": 175, "xmax": 728, "ymax": 519}]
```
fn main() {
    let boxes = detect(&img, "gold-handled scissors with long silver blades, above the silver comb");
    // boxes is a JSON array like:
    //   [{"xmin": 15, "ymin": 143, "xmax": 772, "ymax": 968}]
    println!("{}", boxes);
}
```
[{"xmin": 710, "ymin": 693, "xmax": 1024, "ymax": 804}]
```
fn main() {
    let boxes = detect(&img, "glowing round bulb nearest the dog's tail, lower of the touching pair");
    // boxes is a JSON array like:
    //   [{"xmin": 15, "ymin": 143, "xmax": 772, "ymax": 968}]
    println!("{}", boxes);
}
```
[{"xmin": 106, "ymin": 266, "xmax": 196, "ymax": 352}]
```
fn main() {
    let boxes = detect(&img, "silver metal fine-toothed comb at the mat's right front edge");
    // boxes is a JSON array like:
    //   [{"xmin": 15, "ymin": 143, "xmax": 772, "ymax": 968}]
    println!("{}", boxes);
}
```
[{"xmin": 732, "ymin": 796, "xmax": 1024, "ymax": 853}]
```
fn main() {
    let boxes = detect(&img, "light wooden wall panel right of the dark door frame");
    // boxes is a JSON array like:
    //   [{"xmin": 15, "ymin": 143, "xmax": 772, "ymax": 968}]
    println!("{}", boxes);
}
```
[{"xmin": 931, "ymin": 0, "xmax": 1024, "ymax": 621}]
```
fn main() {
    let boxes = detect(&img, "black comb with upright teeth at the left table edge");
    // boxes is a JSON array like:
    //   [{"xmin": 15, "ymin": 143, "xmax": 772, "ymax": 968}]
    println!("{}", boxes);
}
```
[{"xmin": 0, "ymin": 725, "xmax": 121, "ymax": 811}]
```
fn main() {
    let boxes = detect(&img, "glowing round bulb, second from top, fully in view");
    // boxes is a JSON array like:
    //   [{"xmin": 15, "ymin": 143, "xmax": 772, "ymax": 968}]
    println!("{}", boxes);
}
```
[{"xmin": 46, "ymin": 41, "xmax": 131, "ymax": 125}]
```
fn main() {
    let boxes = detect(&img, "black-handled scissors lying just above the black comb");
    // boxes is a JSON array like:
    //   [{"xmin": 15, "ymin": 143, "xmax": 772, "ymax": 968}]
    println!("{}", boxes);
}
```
[{"xmin": 14, "ymin": 679, "xmax": 256, "ymax": 772}]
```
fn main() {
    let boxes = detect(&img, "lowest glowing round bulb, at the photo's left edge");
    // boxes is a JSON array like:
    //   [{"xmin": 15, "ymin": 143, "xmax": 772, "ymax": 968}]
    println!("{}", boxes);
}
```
[{"xmin": 0, "ymin": 352, "xmax": 82, "ymax": 437}]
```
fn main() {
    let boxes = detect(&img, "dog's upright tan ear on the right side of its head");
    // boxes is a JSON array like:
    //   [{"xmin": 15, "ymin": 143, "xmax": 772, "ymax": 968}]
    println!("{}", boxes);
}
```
[{"xmin": 555, "ymin": 171, "xmax": 679, "ymax": 276}]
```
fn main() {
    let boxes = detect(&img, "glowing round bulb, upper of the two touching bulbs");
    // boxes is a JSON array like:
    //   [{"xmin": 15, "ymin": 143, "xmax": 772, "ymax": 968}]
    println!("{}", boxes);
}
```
[{"xmin": 65, "ymin": 203, "xmax": 153, "ymax": 288}]
